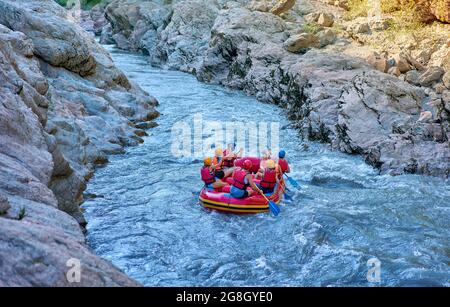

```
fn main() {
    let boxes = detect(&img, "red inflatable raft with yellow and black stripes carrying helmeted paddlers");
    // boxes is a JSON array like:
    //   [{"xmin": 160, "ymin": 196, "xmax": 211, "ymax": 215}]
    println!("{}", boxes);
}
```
[{"xmin": 199, "ymin": 160, "xmax": 285, "ymax": 214}]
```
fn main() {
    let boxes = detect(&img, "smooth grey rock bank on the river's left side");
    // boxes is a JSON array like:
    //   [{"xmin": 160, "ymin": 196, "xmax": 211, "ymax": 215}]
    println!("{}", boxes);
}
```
[{"xmin": 0, "ymin": 0, "xmax": 158, "ymax": 286}]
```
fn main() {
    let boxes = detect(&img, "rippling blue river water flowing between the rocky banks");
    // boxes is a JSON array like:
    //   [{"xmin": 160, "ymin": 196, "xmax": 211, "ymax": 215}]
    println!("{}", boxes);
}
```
[{"xmin": 83, "ymin": 46, "xmax": 450, "ymax": 286}]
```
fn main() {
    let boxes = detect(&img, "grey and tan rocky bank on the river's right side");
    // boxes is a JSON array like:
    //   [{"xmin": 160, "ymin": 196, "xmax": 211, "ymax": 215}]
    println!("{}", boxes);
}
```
[{"xmin": 92, "ymin": 0, "xmax": 450, "ymax": 177}]
